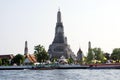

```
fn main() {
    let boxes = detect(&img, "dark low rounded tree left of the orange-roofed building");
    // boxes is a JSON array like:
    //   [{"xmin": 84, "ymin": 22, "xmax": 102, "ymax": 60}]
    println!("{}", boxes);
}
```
[{"xmin": 11, "ymin": 54, "xmax": 25, "ymax": 65}]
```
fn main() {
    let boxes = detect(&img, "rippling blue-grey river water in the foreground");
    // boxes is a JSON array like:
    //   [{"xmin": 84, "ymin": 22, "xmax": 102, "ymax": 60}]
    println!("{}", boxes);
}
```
[{"xmin": 0, "ymin": 69, "xmax": 120, "ymax": 80}]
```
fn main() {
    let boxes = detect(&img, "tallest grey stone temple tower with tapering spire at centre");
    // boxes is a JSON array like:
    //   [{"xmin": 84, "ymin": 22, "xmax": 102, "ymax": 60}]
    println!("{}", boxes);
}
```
[{"xmin": 48, "ymin": 10, "xmax": 76, "ymax": 59}]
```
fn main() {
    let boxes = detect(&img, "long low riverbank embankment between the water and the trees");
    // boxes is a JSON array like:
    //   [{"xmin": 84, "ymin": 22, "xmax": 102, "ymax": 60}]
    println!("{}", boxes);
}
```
[{"xmin": 0, "ymin": 64, "xmax": 120, "ymax": 70}]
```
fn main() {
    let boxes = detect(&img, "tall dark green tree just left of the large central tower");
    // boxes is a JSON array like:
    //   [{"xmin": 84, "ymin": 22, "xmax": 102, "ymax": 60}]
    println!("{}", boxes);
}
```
[{"xmin": 34, "ymin": 45, "xmax": 49, "ymax": 63}]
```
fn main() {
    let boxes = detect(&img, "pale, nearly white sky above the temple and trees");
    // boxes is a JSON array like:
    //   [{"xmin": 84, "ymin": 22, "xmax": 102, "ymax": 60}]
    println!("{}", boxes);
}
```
[{"xmin": 0, "ymin": 0, "xmax": 120, "ymax": 55}]
